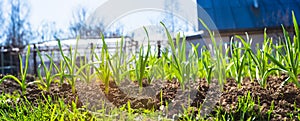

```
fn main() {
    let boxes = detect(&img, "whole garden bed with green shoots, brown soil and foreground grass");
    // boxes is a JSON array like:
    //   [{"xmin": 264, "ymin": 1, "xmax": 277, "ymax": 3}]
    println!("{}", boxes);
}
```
[{"xmin": 0, "ymin": 14, "xmax": 300, "ymax": 121}]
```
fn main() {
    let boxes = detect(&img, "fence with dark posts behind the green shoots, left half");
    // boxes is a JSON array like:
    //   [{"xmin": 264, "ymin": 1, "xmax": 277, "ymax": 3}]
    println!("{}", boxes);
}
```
[{"xmin": 0, "ymin": 40, "xmax": 166, "ymax": 75}]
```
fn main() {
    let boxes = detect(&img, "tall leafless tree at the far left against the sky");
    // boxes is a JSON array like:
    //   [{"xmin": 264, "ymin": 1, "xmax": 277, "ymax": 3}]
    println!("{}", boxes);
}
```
[{"xmin": 5, "ymin": 0, "xmax": 33, "ymax": 48}]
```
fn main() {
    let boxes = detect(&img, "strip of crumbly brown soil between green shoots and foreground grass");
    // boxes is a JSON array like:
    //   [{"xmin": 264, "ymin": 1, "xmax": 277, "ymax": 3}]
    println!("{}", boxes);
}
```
[{"xmin": 0, "ymin": 75, "xmax": 300, "ymax": 120}]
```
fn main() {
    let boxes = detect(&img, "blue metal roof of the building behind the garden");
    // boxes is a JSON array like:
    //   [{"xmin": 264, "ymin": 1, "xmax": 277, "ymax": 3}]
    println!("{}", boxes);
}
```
[{"xmin": 197, "ymin": 0, "xmax": 300, "ymax": 30}]
